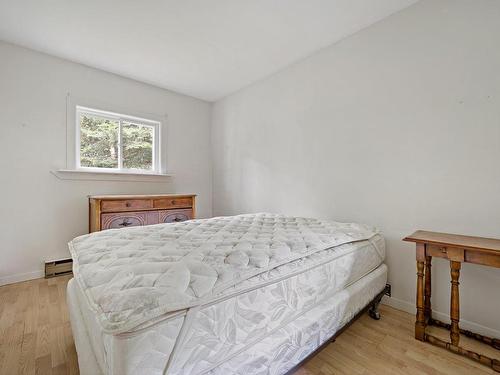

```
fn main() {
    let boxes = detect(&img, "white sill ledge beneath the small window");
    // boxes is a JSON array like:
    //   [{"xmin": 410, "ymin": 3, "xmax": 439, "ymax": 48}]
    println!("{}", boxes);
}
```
[{"xmin": 50, "ymin": 169, "xmax": 173, "ymax": 182}]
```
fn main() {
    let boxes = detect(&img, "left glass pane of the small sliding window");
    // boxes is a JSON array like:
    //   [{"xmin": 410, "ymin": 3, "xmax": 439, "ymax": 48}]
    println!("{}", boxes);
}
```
[{"xmin": 80, "ymin": 114, "xmax": 118, "ymax": 168}]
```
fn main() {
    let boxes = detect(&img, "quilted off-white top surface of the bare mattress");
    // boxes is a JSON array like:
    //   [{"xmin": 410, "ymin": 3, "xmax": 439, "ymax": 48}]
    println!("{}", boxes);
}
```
[{"xmin": 69, "ymin": 213, "xmax": 378, "ymax": 333}]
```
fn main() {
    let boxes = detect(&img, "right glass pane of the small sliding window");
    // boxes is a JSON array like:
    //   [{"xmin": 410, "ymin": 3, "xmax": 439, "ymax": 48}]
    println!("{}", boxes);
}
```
[{"xmin": 122, "ymin": 121, "xmax": 154, "ymax": 170}]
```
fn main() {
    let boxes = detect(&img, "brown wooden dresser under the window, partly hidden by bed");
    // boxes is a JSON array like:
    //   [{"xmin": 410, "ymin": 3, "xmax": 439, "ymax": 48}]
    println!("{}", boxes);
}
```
[{"xmin": 89, "ymin": 194, "xmax": 196, "ymax": 232}]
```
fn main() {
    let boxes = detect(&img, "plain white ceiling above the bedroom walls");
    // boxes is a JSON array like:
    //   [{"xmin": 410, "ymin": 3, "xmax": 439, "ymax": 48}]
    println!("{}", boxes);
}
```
[{"xmin": 0, "ymin": 0, "xmax": 416, "ymax": 101}]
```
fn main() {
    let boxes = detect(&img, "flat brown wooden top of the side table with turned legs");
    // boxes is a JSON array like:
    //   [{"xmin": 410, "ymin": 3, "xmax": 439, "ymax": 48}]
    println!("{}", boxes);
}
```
[{"xmin": 403, "ymin": 230, "xmax": 500, "ymax": 255}]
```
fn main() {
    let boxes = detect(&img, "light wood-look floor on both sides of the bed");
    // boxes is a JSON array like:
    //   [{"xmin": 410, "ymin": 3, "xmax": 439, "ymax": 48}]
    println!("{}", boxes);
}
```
[{"xmin": 0, "ymin": 276, "xmax": 498, "ymax": 375}]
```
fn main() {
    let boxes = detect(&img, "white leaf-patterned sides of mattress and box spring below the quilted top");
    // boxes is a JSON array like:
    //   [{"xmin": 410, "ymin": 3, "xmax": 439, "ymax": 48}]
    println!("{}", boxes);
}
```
[{"xmin": 68, "ymin": 235, "xmax": 386, "ymax": 375}]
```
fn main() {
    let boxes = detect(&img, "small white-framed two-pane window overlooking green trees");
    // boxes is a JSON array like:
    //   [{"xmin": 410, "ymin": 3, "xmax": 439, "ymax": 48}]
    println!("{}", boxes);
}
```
[{"xmin": 76, "ymin": 106, "xmax": 160, "ymax": 173}]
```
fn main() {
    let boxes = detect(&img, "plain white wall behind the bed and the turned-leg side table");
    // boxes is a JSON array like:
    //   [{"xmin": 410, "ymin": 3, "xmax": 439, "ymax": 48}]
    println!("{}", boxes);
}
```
[{"xmin": 212, "ymin": 0, "xmax": 500, "ymax": 335}]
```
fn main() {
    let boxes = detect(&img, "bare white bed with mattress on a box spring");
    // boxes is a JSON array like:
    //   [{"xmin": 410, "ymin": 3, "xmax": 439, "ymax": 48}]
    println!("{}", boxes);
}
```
[{"xmin": 67, "ymin": 214, "xmax": 387, "ymax": 375}]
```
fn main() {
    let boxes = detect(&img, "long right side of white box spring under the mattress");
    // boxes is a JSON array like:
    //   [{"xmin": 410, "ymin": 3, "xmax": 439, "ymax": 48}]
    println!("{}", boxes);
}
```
[{"xmin": 207, "ymin": 264, "xmax": 387, "ymax": 375}]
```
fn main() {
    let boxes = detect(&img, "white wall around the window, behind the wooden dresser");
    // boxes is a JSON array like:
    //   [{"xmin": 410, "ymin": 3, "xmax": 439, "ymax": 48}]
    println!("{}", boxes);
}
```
[{"xmin": 0, "ymin": 42, "xmax": 212, "ymax": 284}]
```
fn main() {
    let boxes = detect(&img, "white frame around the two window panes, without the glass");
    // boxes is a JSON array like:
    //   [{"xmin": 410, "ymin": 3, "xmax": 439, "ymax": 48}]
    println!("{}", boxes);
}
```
[{"xmin": 75, "ymin": 105, "xmax": 162, "ymax": 174}]
